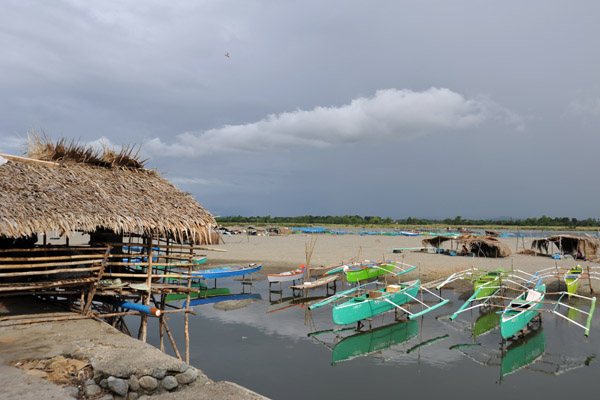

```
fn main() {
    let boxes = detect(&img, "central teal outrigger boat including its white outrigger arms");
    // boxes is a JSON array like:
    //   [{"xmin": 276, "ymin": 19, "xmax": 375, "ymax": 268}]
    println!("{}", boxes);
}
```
[{"xmin": 309, "ymin": 268, "xmax": 448, "ymax": 325}]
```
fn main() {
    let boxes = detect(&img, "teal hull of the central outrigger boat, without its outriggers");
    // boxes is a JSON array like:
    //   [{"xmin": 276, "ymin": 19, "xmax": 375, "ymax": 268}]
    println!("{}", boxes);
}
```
[{"xmin": 332, "ymin": 279, "xmax": 419, "ymax": 325}]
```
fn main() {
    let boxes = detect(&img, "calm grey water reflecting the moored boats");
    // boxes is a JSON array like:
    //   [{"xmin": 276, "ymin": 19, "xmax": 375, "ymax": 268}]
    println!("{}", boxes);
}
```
[{"xmin": 148, "ymin": 279, "xmax": 600, "ymax": 400}]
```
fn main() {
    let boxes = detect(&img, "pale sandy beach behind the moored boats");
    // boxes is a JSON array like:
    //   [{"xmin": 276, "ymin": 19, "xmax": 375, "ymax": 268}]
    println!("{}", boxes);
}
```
[{"xmin": 205, "ymin": 234, "xmax": 592, "ymax": 289}]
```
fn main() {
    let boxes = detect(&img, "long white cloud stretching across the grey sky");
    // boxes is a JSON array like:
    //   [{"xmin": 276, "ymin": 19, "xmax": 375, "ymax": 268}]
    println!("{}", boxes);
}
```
[{"xmin": 144, "ymin": 88, "xmax": 510, "ymax": 157}]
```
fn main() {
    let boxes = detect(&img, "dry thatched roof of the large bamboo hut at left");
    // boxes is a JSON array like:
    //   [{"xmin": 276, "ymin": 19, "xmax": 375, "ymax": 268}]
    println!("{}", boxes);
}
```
[{"xmin": 0, "ymin": 139, "xmax": 216, "ymax": 244}]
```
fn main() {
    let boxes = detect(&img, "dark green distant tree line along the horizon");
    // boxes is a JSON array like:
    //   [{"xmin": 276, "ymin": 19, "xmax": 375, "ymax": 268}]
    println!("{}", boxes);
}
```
[{"xmin": 215, "ymin": 215, "xmax": 600, "ymax": 228}]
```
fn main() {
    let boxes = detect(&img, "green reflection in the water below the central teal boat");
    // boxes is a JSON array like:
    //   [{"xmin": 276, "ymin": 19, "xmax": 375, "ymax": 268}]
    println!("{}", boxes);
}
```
[{"xmin": 331, "ymin": 320, "xmax": 419, "ymax": 365}]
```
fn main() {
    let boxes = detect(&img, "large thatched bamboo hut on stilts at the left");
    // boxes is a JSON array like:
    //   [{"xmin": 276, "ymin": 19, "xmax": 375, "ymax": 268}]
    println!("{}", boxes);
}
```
[{"xmin": 0, "ymin": 135, "xmax": 218, "ymax": 344}]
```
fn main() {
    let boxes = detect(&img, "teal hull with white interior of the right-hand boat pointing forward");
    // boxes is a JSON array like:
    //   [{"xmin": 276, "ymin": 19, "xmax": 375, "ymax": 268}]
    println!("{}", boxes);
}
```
[{"xmin": 500, "ymin": 284, "xmax": 546, "ymax": 339}]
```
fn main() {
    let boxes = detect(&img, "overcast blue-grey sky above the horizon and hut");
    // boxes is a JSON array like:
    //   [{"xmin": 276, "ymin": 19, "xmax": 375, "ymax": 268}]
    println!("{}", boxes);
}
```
[{"xmin": 0, "ymin": 0, "xmax": 600, "ymax": 218}]
